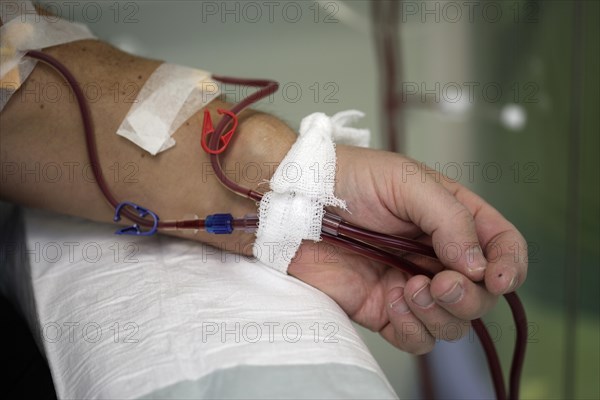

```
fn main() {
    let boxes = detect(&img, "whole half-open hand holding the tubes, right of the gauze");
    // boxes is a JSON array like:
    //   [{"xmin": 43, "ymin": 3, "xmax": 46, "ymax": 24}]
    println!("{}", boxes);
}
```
[{"xmin": 288, "ymin": 146, "xmax": 527, "ymax": 354}]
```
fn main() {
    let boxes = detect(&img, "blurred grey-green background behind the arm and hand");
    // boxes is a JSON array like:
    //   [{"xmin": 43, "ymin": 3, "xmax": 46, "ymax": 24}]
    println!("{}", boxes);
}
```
[{"xmin": 42, "ymin": 0, "xmax": 600, "ymax": 399}]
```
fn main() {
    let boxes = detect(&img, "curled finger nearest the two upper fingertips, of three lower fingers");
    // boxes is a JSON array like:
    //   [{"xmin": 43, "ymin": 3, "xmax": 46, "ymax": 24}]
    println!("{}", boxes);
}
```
[{"xmin": 431, "ymin": 270, "xmax": 498, "ymax": 321}]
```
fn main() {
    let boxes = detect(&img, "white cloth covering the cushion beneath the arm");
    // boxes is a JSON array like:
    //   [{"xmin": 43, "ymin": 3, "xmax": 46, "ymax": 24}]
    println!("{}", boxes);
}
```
[{"xmin": 10, "ymin": 210, "xmax": 391, "ymax": 399}]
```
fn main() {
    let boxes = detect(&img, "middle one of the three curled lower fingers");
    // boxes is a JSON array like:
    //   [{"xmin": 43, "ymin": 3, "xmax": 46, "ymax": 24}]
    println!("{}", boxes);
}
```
[{"xmin": 404, "ymin": 275, "xmax": 471, "ymax": 340}]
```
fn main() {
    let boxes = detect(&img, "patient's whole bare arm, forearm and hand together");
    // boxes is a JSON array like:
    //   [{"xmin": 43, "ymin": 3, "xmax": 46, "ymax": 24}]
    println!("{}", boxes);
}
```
[{"xmin": 0, "ymin": 41, "xmax": 527, "ymax": 353}]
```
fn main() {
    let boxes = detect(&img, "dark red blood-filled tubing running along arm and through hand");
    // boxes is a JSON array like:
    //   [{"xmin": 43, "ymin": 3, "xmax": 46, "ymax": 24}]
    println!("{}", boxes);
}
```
[{"xmin": 26, "ymin": 50, "xmax": 527, "ymax": 400}]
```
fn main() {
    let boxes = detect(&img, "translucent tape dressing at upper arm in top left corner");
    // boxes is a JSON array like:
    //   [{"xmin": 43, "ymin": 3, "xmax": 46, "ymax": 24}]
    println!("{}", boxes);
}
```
[{"xmin": 0, "ymin": 0, "xmax": 96, "ymax": 111}]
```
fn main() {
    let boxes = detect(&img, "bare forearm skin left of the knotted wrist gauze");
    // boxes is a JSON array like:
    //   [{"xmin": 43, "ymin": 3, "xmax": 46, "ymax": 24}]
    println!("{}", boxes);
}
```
[{"xmin": 0, "ymin": 41, "xmax": 294, "ymax": 248}]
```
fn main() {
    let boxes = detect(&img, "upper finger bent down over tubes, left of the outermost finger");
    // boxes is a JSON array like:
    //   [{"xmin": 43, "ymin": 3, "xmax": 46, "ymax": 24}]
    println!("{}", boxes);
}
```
[{"xmin": 394, "ymin": 163, "xmax": 487, "ymax": 280}]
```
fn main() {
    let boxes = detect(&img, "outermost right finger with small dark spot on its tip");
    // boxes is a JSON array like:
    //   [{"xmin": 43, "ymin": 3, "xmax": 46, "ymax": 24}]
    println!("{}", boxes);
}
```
[{"xmin": 438, "ymin": 182, "xmax": 527, "ymax": 295}]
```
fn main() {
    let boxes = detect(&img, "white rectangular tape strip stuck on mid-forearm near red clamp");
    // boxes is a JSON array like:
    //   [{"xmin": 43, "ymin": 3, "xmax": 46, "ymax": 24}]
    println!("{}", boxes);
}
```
[{"xmin": 117, "ymin": 64, "xmax": 220, "ymax": 155}]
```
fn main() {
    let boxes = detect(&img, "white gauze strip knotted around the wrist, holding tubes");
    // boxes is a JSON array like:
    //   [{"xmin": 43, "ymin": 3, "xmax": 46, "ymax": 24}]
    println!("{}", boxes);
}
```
[{"xmin": 253, "ymin": 110, "xmax": 370, "ymax": 273}]
